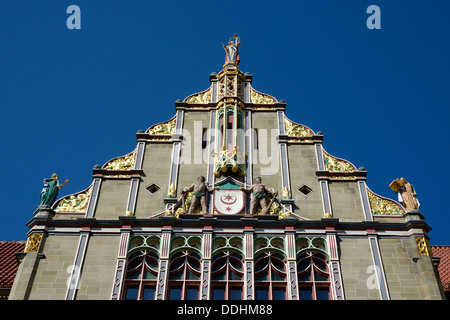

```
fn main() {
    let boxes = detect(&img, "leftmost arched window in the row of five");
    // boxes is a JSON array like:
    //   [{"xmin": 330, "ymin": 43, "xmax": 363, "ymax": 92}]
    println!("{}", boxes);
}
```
[{"xmin": 123, "ymin": 250, "xmax": 159, "ymax": 300}]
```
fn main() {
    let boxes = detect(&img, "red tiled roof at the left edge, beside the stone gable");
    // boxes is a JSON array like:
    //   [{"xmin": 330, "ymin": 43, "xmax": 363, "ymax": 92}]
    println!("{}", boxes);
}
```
[{"xmin": 0, "ymin": 241, "xmax": 26, "ymax": 288}]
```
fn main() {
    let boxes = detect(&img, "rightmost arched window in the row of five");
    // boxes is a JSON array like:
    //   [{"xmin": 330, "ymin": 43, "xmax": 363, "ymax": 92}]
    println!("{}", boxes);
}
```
[{"xmin": 297, "ymin": 252, "xmax": 330, "ymax": 300}]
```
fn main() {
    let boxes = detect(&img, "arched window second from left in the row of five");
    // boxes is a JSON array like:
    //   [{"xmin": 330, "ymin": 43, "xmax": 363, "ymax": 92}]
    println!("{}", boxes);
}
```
[{"xmin": 167, "ymin": 250, "xmax": 202, "ymax": 300}]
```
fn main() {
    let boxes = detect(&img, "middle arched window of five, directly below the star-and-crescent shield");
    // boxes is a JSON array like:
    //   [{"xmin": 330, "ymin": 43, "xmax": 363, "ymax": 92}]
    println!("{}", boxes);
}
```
[{"xmin": 211, "ymin": 251, "xmax": 244, "ymax": 300}]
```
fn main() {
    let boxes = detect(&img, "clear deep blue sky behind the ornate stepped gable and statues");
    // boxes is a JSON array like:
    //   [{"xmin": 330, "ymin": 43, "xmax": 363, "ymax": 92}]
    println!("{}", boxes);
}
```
[{"xmin": 0, "ymin": 0, "xmax": 450, "ymax": 245}]
